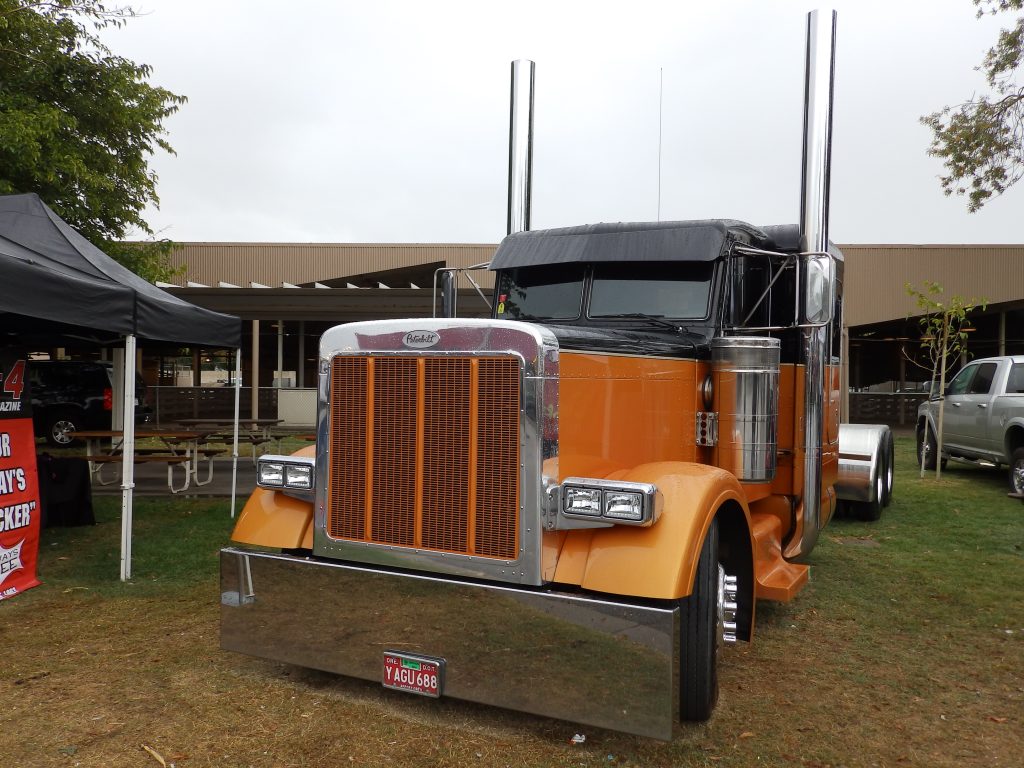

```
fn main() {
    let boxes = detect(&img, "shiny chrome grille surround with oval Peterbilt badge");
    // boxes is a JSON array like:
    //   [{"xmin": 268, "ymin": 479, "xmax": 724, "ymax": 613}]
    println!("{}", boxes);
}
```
[{"xmin": 313, "ymin": 318, "xmax": 559, "ymax": 586}]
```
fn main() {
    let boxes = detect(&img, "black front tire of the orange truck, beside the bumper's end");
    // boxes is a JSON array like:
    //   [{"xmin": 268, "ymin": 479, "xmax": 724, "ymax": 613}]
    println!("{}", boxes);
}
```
[{"xmin": 679, "ymin": 519, "xmax": 719, "ymax": 722}]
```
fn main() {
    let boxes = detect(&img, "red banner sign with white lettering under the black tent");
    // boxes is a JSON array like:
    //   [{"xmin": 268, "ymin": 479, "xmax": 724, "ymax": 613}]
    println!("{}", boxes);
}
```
[{"xmin": 0, "ymin": 350, "xmax": 42, "ymax": 600}]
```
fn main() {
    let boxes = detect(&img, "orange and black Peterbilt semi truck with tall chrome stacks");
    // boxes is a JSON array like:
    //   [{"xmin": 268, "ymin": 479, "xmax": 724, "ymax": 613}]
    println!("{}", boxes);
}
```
[{"xmin": 221, "ymin": 12, "xmax": 892, "ymax": 738}]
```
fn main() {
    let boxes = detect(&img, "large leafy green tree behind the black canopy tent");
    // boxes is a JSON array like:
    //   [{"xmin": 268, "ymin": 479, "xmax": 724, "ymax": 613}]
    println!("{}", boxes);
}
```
[{"xmin": 0, "ymin": 0, "xmax": 185, "ymax": 280}]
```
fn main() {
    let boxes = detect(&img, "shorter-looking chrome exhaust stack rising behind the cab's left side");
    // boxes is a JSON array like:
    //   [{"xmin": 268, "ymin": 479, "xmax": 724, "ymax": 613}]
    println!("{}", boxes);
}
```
[{"xmin": 508, "ymin": 59, "xmax": 536, "ymax": 234}]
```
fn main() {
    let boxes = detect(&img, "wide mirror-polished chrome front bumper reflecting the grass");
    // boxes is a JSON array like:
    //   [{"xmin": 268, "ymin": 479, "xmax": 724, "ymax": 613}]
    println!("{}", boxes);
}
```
[{"xmin": 220, "ymin": 548, "xmax": 680, "ymax": 740}]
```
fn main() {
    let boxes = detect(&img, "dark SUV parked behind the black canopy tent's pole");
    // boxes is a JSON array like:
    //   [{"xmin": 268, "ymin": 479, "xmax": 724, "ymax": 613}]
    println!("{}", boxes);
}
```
[{"xmin": 29, "ymin": 360, "xmax": 150, "ymax": 445}]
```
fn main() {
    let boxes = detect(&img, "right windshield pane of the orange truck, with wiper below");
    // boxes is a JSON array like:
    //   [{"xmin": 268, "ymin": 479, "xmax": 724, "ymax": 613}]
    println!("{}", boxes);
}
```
[{"xmin": 588, "ymin": 261, "xmax": 715, "ymax": 319}]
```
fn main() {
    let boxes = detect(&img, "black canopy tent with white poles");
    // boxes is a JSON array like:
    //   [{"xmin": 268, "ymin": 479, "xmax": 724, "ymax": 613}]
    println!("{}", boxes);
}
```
[{"xmin": 0, "ymin": 194, "xmax": 242, "ymax": 580}]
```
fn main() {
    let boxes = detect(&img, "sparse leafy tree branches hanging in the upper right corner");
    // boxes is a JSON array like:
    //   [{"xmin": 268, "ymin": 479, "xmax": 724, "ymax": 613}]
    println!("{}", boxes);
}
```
[{"xmin": 921, "ymin": 0, "xmax": 1024, "ymax": 213}]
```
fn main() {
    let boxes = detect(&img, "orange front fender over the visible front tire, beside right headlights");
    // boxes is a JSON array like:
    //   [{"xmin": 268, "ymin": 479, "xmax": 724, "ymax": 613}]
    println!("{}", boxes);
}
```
[{"xmin": 554, "ymin": 462, "xmax": 753, "ymax": 600}]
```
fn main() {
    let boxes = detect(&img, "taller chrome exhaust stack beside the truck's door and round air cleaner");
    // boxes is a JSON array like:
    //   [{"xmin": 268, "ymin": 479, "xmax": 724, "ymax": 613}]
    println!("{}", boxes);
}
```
[{"xmin": 786, "ymin": 10, "xmax": 839, "ymax": 557}]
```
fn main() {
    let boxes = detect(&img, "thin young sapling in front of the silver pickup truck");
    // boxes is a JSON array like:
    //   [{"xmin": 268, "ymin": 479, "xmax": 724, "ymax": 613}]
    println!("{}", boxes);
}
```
[{"xmin": 904, "ymin": 281, "xmax": 985, "ymax": 479}]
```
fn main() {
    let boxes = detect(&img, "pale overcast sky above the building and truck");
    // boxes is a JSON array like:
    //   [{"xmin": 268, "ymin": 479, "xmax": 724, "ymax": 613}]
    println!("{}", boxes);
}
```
[{"xmin": 104, "ymin": 0, "xmax": 1024, "ymax": 244}]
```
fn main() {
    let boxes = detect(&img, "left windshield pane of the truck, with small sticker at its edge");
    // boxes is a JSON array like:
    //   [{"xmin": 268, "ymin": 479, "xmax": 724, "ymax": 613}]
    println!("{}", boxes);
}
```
[{"xmin": 496, "ymin": 264, "xmax": 584, "ymax": 319}]
